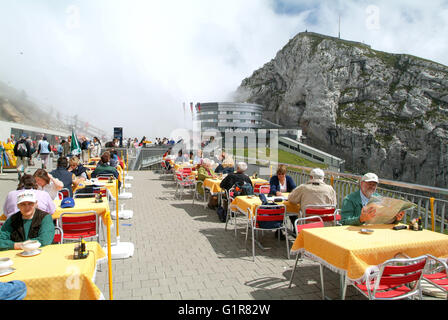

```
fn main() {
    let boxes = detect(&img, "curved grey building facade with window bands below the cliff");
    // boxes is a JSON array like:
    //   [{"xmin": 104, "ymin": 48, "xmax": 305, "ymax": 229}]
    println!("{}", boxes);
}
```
[{"xmin": 195, "ymin": 102, "xmax": 264, "ymax": 132}]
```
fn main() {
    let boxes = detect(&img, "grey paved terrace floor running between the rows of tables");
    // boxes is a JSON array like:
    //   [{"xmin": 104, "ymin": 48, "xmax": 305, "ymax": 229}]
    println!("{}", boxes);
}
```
[{"xmin": 0, "ymin": 169, "xmax": 442, "ymax": 300}]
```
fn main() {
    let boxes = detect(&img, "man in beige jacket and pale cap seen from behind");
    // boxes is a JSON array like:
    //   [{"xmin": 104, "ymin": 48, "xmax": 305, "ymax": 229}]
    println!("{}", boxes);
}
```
[{"xmin": 288, "ymin": 168, "xmax": 337, "ymax": 232}]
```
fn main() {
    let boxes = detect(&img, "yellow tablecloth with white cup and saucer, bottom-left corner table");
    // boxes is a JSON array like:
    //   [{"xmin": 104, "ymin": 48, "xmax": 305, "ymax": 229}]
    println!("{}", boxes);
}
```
[{"xmin": 0, "ymin": 242, "xmax": 106, "ymax": 300}]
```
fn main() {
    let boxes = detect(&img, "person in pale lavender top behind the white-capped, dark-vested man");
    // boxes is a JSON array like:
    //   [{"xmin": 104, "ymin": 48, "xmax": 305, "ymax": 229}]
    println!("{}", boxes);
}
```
[{"xmin": 3, "ymin": 174, "xmax": 56, "ymax": 218}]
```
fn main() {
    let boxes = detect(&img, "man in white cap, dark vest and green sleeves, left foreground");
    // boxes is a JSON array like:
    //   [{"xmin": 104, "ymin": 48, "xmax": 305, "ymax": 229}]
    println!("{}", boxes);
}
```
[{"xmin": 0, "ymin": 190, "xmax": 54, "ymax": 250}]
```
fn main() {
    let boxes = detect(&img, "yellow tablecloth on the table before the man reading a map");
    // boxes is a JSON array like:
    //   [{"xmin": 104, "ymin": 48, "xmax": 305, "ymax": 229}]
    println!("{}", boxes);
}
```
[{"xmin": 291, "ymin": 224, "xmax": 448, "ymax": 279}]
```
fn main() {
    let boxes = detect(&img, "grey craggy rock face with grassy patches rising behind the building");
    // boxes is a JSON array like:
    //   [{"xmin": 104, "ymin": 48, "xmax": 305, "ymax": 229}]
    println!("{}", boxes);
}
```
[{"xmin": 235, "ymin": 32, "xmax": 448, "ymax": 188}]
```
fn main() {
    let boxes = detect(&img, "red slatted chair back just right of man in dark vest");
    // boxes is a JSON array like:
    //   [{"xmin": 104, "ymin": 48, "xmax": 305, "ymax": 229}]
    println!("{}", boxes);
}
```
[{"xmin": 59, "ymin": 211, "xmax": 99, "ymax": 241}]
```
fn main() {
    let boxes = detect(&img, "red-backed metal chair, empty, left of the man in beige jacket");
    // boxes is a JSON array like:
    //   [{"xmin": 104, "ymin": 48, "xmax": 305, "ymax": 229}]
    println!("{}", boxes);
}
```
[{"xmin": 246, "ymin": 204, "xmax": 289, "ymax": 262}]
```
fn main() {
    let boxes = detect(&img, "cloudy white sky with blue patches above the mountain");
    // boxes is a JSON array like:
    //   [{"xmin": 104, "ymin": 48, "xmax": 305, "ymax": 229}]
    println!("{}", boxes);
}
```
[{"xmin": 0, "ymin": 0, "xmax": 448, "ymax": 138}]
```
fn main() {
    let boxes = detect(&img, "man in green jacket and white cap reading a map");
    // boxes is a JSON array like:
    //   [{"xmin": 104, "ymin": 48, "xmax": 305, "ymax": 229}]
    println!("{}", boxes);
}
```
[{"xmin": 341, "ymin": 172, "xmax": 404, "ymax": 226}]
